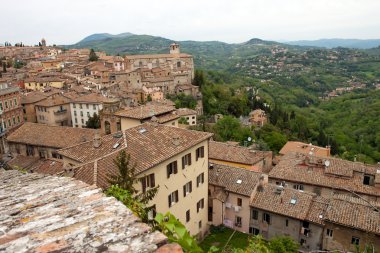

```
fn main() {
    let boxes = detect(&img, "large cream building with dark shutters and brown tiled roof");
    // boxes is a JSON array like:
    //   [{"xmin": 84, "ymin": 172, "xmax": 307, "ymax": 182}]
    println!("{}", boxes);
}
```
[{"xmin": 58, "ymin": 123, "xmax": 212, "ymax": 238}]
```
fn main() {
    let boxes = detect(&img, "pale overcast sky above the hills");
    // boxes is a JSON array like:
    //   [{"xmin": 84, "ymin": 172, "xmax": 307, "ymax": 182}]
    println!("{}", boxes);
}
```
[{"xmin": 0, "ymin": 0, "xmax": 380, "ymax": 44}]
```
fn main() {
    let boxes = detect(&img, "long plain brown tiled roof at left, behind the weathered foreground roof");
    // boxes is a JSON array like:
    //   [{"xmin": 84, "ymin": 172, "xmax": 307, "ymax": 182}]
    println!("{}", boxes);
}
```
[{"xmin": 7, "ymin": 122, "xmax": 97, "ymax": 148}]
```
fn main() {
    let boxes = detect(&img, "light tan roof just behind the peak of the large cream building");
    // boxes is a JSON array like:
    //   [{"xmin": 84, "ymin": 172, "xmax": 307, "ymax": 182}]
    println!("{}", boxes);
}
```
[{"xmin": 115, "ymin": 105, "xmax": 175, "ymax": 120}]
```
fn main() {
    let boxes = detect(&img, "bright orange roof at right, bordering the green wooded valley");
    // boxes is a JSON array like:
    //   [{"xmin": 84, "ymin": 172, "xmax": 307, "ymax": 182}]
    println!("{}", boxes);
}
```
[{"xmin": 279, "ymin": 141, "xmax": 330, "ymax": 157}]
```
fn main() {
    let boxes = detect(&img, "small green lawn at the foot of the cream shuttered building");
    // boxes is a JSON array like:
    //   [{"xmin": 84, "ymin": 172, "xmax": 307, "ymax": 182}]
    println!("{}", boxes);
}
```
[{"xmin": 200, "ymin": 226, "xmax": 250, "ymax": 252}]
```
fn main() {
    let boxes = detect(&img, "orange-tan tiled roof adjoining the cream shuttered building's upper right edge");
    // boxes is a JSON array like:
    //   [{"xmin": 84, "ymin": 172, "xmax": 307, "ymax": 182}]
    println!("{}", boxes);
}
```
[{"xmin": 209, "ymin": 141, "xmax": 272, "ymax": 165}]
